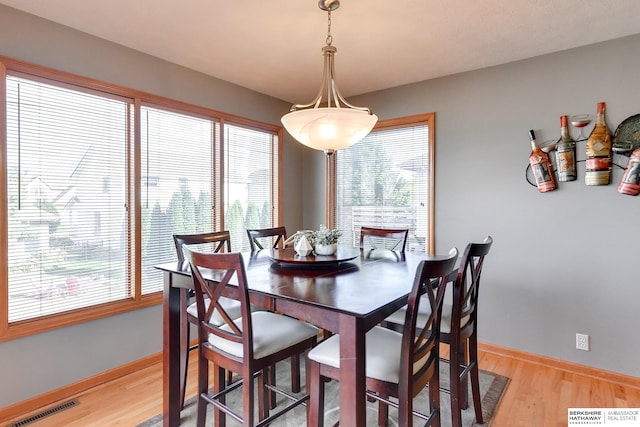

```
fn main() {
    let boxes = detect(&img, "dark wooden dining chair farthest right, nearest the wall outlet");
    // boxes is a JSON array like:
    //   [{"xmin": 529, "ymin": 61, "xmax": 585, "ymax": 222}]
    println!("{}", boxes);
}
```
[{"xmin": 382, "ymin": 236, "xmax": 493, "ymax": 427}]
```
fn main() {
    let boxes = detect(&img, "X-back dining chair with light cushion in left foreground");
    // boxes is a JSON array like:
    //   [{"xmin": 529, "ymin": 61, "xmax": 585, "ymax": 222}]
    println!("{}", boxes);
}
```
[{"xmin": 183, "ymin": 247, "xmax": 318, "ymax": 427}]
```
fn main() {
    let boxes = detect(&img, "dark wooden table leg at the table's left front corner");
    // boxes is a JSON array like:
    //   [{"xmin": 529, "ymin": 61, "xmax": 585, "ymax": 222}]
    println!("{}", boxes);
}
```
[{"xmin": 162, "ymin": 272, "xmax": 182, "ymax": 427}]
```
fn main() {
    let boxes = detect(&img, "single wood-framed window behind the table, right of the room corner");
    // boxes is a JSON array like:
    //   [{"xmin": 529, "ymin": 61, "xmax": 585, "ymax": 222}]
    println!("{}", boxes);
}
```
[{"xmin": 336, "ymin": 113, "xmax": 434, "ymax": 253}]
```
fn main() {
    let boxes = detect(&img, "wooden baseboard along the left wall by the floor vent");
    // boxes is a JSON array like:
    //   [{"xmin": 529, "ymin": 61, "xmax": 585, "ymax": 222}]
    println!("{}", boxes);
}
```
[{"xmin": 0, "ymin": 353, "xmax": 162, "ymax": 422}]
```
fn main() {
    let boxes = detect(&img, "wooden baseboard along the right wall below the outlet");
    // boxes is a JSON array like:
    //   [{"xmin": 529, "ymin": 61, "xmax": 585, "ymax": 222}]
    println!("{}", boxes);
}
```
[{"xmin": 478, "ymin": 342, "xmax": 640, "ymax": 389}]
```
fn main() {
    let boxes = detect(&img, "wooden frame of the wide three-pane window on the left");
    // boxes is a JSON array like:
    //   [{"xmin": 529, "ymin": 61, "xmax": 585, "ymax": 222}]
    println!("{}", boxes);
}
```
[{"xmin": 0, "ymin": 55, "xmax": 283, "ymax": 342}]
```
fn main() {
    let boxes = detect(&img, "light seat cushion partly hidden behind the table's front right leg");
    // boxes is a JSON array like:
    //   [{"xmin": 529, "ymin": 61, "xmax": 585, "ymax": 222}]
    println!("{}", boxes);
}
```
[{"xmin": 308, "ymin": 326, "xmax": 426, "ymax": 384}]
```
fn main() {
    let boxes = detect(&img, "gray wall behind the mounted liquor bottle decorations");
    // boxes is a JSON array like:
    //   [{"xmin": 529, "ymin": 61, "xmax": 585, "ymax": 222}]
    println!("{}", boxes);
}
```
[{"xmin": 304, "ymin": 35, "xmax": 640, "ymax": 376}]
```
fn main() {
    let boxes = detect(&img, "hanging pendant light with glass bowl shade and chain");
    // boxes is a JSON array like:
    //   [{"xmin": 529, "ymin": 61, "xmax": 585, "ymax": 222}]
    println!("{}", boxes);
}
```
[{"xmin": 281, "ymin": 0, "xmax": 378, "ymax": 153}]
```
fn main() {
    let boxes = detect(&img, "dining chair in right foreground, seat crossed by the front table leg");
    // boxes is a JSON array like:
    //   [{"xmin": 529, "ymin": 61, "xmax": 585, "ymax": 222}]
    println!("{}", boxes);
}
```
[{"xmin": 307, "ymin": 248, "xmax": 458, "ymax": 427}]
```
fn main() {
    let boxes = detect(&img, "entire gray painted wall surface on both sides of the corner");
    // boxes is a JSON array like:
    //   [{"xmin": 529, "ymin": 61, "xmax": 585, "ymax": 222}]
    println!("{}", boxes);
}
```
[{"xmin": 0, "ymin": 1, "xmax": 640, "ymax": 408}]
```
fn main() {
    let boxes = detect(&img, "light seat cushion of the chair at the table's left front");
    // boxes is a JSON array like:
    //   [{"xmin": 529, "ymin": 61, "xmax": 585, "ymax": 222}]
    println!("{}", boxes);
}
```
[{"xmin": 209, "ymin": 311, "xmax": 318, "ymax": 359}]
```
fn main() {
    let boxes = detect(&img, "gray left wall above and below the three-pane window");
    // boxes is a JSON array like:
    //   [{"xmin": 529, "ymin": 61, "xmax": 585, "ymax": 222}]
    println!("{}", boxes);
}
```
[{"xmin": 0, "ymin": 5, "xmax": 302, "ymax": 408}]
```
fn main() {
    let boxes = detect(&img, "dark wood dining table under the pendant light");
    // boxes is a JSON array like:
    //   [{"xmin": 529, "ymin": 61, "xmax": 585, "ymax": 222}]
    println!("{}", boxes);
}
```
[{"xmin": 156, "ymin": 247, "xmax": 429, "ymax": 427}]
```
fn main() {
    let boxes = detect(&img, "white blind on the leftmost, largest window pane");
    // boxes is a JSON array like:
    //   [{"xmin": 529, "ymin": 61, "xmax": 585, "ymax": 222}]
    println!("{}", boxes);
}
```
[{"xmin": 6, "ymin": 76, "xmax": 132, "ymax": 322}]
